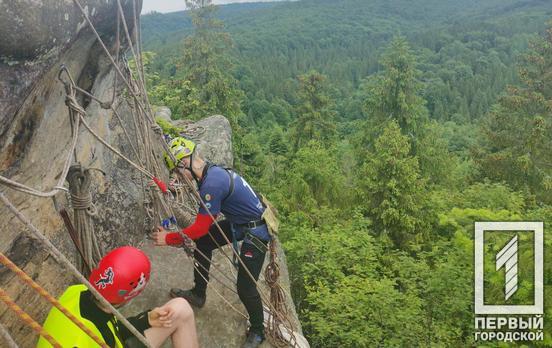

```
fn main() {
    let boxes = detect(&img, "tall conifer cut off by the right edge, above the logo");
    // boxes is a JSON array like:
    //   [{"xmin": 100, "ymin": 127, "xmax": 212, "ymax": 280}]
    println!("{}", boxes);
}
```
[{"xmin": 479, "ymin": 23, "xmax": 552, "ymax": 203}]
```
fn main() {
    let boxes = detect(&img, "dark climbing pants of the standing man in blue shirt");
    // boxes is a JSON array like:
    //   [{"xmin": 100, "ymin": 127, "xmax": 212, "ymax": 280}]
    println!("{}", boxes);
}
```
[{"xmin": 193, "ymin": 220, "xmax": 266, "ymax": 334}]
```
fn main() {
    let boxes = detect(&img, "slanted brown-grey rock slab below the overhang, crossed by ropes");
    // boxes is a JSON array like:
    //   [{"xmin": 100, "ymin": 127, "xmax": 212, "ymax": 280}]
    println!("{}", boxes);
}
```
[{"xmin": 0, "ymin": 31, "xmax": 150, "ymax": 347}]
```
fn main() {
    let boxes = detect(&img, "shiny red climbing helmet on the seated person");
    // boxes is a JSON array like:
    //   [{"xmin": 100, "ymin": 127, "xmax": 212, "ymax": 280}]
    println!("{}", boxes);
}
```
[{"xmin": 89, "ymin": 246, "xmax": 151, "ymax": 304}]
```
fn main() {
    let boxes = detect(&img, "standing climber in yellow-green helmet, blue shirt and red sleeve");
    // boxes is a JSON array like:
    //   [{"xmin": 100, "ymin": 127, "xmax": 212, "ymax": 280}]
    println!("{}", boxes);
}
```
[{"xmin": 153, "ymin": 138, "xmax": 270, "ymax": 348}]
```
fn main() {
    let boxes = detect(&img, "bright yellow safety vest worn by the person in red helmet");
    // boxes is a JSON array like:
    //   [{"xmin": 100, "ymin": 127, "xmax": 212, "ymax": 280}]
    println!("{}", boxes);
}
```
[{"xmin": 36, "ymin": 285, "xmax": 123, "ymax": 348}]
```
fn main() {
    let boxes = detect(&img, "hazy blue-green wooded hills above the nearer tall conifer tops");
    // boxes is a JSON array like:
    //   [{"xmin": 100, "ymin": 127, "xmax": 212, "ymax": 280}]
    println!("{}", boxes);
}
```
[{"xmin": 142, "ymin": 0, "xmax": 552, "ymax": 119}]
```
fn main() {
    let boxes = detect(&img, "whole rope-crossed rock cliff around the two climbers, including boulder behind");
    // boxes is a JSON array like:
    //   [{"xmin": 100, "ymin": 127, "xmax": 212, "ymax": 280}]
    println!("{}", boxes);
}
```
[{"xmin": 0, "ymin": 0, "xmax": 306, "ymax": 347}]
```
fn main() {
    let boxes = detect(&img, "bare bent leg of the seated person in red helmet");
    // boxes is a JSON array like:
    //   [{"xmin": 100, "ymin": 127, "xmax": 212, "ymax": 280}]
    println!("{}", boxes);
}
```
[{"xmin": 144, "ymin": 298, "xmax": 199, "ymax": 348}]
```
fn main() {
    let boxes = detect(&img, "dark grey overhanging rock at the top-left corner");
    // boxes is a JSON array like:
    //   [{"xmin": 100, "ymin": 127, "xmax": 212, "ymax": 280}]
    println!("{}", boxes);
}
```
[{"xmin": 0, "ymin": 0, "xmax": 142, "ymax": 151}]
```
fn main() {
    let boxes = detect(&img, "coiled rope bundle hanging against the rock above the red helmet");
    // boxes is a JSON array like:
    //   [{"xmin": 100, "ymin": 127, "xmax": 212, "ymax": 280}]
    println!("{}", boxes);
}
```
[{"xmin": 67, "ymin": 164, "xmax": 103, "ymax": 276}]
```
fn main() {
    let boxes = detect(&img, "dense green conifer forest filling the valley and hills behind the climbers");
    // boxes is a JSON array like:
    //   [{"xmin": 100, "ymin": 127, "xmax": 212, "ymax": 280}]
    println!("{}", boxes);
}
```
[{"xmin": 142, "ymin": 0, "xmax": 552, "ymax": 347}]
